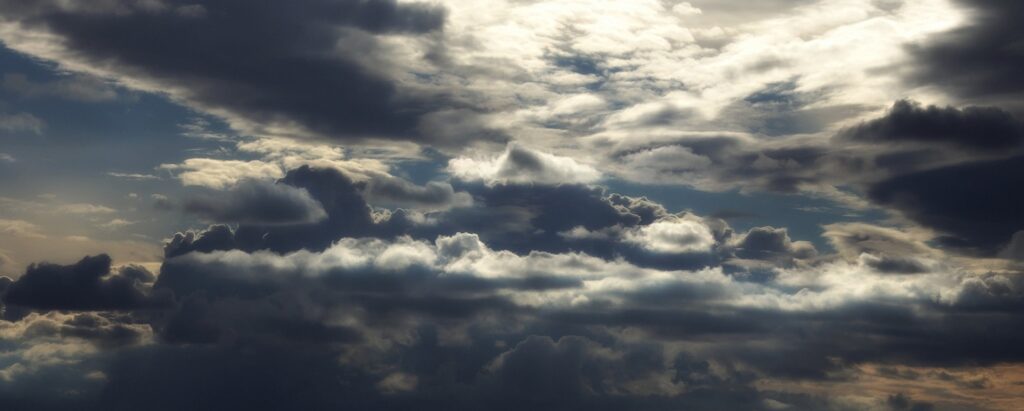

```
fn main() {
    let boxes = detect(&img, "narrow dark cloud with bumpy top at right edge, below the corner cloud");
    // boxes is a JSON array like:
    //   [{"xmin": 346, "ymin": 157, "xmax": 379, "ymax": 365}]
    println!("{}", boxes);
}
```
[{"xmin": 840, "ymin": 99, "xmax": 1024, "ymax": 150}]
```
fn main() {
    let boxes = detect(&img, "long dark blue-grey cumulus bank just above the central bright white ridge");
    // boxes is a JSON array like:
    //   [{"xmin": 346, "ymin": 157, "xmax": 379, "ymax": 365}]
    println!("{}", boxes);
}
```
[{"xmin": 166, "ymin": 167, "xmax": 669, "ymax": 264}]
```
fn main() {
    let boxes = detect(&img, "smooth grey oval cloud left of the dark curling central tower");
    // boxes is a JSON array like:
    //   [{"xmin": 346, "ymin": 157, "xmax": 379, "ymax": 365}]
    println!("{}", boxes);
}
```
[{"xmin": 182, "ymin": 180, "xmax": 327, "ymax": 224}]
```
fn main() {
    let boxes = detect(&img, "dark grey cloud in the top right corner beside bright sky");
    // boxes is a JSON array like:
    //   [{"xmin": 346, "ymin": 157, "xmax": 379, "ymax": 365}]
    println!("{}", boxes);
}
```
[{"xmin": 910, "ymin": 0, "xmax": 1024, "ymax": 104}]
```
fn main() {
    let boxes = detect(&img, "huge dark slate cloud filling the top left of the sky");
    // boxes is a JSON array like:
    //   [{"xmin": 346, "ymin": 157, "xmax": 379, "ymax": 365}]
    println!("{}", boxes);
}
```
[{"xmin": 0, "ymin": 0, "xmax": 468, "ymax": 139}]
